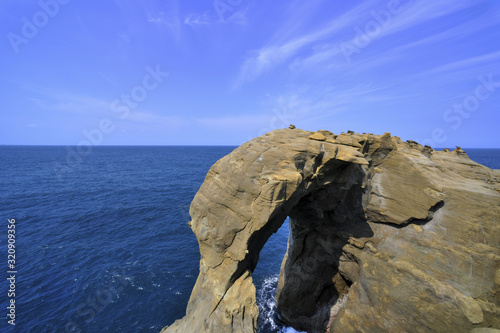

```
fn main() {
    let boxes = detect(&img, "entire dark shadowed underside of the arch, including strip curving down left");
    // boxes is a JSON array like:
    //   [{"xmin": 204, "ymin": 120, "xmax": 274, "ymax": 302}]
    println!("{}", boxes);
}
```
[{"xmin": 235, "ymin": 154, "xmax": 373, "ymax": 333}]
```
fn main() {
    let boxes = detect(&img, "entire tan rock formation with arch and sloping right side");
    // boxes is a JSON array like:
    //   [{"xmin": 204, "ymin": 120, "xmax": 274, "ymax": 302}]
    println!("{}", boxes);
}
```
[{"xmin": 162, "ymin": 127, "xmax": 500, "ymax": 333}]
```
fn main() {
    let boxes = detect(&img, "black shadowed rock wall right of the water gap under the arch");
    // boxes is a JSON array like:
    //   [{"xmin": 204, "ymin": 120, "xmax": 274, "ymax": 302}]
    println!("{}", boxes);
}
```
[{"xmin": 277, "ymin": 163, "xmax": 373, "ymax": 332}]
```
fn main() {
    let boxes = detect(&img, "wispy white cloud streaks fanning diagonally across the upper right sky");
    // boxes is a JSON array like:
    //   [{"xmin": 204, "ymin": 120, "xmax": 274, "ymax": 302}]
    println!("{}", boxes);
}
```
[{"xmin": 234, "ymin": 0, "xmax": 492, "ymax": 87}]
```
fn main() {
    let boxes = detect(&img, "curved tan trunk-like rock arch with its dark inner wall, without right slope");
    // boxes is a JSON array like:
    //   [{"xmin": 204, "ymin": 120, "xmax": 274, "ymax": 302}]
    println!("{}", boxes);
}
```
[{"xmin": 162, "ymin": 130, "xmax": 369, "ymax": 332}]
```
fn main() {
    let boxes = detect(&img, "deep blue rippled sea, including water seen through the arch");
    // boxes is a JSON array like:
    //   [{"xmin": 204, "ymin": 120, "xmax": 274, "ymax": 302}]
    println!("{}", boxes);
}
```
[{"xmin": 0, "ymin": 146, "xmax": 500, "ymax": 333}]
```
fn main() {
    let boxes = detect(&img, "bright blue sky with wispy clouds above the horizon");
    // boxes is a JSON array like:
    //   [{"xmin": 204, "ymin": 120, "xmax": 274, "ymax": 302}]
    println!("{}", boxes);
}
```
[{"xmin": 0, "ymin": 0, "xmax": 500, "ymax": 147}]
